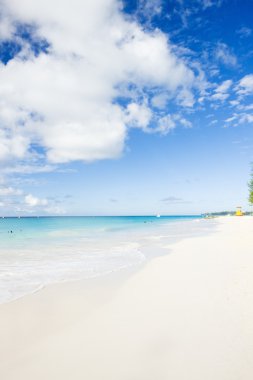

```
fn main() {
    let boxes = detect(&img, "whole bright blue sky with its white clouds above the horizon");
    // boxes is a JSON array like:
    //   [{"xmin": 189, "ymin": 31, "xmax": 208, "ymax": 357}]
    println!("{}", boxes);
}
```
[{"xmin": 0, "ymin": 0, "xmax": 253, "ymax": 216}]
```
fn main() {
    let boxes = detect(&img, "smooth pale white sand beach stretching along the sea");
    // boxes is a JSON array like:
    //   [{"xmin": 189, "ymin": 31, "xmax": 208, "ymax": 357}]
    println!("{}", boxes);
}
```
[{"xmin": 0, "ymin": 217, "xmax": 253, "ymax": 380}]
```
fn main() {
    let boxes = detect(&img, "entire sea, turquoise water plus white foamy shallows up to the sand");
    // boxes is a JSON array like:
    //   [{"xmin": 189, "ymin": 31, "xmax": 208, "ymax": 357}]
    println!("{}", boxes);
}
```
[{"xmin": 0, "ymin": 216, "xmax": 213, "ymax": 303}]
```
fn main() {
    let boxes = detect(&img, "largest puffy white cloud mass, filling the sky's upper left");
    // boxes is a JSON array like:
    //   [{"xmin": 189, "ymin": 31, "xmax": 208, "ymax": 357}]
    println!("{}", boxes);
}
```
[{"xmin": 0, "ymin": 0, "xmax": 194, "ymax": 163}]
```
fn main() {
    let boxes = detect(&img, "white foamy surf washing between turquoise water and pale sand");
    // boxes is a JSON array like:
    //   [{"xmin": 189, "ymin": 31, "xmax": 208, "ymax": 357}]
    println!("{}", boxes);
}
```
[{"xmin": 0, "ymin": 218, "xmax": 215, "ymax": 305}]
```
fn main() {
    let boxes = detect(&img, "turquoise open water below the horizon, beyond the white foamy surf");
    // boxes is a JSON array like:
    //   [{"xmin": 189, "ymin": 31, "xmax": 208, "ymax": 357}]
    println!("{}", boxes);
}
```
[{"xmin": 0, "ymin": 216, "xmax": 200, "ymax": 249}]
